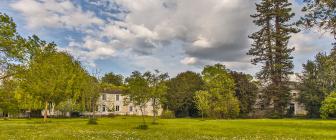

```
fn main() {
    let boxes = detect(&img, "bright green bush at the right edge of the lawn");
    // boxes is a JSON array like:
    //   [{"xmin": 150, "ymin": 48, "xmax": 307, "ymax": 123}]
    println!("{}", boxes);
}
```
[{"xmin": 321, "ymin": 92, "xmax": 336, "ymax": 119}]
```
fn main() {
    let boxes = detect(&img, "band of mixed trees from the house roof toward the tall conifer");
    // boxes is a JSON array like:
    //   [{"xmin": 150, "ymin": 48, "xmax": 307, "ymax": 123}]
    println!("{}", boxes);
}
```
[{"xmin": 102, "ymin": 64, "xmax": 258, "ymax": 118}]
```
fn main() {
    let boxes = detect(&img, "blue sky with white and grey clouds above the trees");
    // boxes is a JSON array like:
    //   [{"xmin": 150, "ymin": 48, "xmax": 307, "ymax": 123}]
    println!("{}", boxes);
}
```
[{"xmin": 0, "ymin": 0, "xmax": 332, "ymax": 76}]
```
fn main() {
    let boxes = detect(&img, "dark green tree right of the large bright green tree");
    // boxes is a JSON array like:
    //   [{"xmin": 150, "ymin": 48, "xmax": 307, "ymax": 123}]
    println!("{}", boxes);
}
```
[{"xmin": 230, "ymin": 71, "xmax": 259, "ymax": 116}]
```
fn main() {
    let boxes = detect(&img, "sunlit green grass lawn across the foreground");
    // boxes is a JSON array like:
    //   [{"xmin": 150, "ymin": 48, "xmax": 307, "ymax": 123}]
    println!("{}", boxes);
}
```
[{"xmin": 0, "ymin": 117, "xmax": 336, "ymax": 140}]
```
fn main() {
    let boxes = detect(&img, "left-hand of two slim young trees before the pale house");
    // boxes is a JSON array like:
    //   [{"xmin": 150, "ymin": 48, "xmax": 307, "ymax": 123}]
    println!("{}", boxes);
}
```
[{"xmin": 125, "ymin": 71, "xmax": 151, "ymax": 125}]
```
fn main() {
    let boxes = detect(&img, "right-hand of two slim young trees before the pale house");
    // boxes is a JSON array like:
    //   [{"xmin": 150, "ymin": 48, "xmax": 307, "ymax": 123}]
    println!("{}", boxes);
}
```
[{"xmin": 143, "ymin": 70, "xmax": 169, "ymax": 124}]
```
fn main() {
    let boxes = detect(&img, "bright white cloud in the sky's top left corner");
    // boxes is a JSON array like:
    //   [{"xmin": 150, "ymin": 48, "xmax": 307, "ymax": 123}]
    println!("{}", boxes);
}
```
[{"xmin": 10, "ymin": 0, "xmax": 104, "ymax": 29}]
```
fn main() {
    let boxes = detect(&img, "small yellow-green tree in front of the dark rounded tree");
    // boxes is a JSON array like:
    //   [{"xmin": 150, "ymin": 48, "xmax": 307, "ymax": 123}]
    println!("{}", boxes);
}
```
[{"xmin": 194, "ymin": 90, "xmax": 210, "ymax": 119}]
